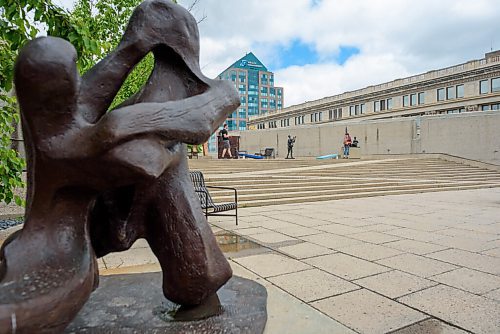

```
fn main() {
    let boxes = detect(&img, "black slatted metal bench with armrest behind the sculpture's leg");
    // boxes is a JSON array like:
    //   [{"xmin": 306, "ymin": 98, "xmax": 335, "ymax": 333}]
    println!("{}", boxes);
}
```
[{"xmin": 189, "ymin": 171, "xmax": 238, "ymax": 225}]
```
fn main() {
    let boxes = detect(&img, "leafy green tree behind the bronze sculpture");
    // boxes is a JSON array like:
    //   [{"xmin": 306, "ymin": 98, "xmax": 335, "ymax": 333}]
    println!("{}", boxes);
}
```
[{"xmin": 0, "ymin": 0, "xmax": 186, "ymax": 205}]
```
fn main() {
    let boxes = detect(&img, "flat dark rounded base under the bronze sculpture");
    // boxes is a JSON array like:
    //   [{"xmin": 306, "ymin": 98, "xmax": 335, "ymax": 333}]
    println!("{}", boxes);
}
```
[{"xmin": 65, "ymin": 272, "xmax": 267, "ymax": 334}]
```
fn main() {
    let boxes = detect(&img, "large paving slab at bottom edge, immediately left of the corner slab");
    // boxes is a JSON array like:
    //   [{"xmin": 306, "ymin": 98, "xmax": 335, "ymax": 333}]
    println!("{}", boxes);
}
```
[{"xmin": 311, "ymin": 289, "xmax": 427, "ymax": 334}]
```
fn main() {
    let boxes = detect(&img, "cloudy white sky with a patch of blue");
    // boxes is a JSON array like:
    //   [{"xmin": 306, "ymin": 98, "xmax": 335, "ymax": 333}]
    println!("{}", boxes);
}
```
[{"xmin": 55, "ymin": 0, "xmax": 500, "ymax": 106}]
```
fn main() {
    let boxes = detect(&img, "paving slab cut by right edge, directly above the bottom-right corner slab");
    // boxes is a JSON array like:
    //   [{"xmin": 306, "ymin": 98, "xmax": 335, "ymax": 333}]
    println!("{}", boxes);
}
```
[{"xmin": 430, "ymin": 268, "xmax": 500, "ymax": 295}]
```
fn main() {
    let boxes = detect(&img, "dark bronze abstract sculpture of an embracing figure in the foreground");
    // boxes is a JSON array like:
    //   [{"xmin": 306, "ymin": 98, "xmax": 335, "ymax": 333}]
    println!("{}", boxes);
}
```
[{"xmin": 0, "ymin": 0, "xmax": 239, "ymax": 333}]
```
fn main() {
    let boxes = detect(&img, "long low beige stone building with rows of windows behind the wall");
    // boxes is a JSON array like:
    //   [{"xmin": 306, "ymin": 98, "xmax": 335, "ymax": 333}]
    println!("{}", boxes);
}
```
[{"xmin": 248, "ymin": 51, "xmax": 500, "ymax": 130}]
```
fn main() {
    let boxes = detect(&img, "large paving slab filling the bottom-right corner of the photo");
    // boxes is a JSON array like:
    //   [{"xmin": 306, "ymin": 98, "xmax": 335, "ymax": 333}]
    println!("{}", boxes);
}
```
[{"xmin": 398, "ymin": 285, "xmax": 500, "ymax": 334}]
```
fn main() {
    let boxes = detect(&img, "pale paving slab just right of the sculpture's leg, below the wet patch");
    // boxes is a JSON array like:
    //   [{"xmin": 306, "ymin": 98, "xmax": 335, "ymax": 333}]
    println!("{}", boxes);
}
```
[{"xmin": 233, "ymin": 254, "xmax": 312, "ymax": 277}]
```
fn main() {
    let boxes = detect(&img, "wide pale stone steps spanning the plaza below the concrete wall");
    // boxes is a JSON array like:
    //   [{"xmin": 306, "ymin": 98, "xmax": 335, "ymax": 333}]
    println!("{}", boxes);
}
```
[{"xmin": 189, "ymin": 158, "xmax": 500, "ymax": 207}]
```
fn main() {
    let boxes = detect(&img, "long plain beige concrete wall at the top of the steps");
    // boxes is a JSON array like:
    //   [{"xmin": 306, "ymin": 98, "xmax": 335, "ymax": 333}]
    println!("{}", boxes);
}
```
[{"xmin": 240, "ymin": 111, "xmax": 500, "ymax": 163}]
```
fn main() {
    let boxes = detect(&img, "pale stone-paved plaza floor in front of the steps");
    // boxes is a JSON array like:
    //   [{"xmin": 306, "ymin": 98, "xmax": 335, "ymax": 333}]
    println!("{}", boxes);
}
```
[{"xmin": 0, "ymin": 188, "xmax": 500, "ymax": 334}]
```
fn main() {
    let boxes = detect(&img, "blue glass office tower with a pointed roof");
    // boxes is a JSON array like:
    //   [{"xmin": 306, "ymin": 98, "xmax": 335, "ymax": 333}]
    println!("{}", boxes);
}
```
[{"xmin": 218, "ymin": 52, "xmax": 284, "ymax": 131}]
